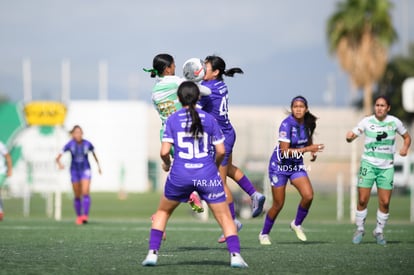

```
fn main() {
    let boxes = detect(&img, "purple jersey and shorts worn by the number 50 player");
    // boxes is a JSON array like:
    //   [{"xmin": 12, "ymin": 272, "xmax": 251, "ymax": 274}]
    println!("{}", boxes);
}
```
[{"xmin": 162, "ymin": 108, "xmax": 226, "ymax": 203}]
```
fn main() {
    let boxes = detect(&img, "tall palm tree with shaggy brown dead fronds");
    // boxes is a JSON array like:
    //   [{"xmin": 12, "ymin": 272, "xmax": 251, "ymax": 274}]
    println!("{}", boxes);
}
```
[{"xmin": 326, "ymin": 0, "xmax": 397, "ymax": 115}]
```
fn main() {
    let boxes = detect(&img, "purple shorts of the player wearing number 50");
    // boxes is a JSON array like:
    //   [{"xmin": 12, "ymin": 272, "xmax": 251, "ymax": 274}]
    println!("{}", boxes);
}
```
[{"xmin": 164, "ymin": 170, "xmax": 226, "ymax": 203}]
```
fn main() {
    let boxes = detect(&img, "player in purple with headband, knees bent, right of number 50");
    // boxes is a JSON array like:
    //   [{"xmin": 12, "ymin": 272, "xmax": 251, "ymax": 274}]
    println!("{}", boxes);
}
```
[{"xmin": 259, "ymin": 96, "xmax": 324, "ymax": 245}]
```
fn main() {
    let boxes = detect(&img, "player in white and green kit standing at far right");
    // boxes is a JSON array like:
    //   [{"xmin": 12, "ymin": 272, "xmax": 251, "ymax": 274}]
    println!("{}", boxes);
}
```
[{"xmin": 346, "ymin": 96, "xmax": 411, "ymax": 245}]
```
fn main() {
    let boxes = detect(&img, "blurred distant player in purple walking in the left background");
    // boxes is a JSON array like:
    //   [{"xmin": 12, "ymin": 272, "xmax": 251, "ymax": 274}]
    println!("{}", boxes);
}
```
[{"xmin": 56, "ymin": 125, "xmax": 102, "ymax": 224}]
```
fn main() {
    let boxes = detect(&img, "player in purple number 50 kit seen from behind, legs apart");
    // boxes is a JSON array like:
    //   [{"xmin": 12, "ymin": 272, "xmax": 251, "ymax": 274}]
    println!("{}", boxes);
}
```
[{"xmin": 142, "ymin": 81, "xmax": 247, "ymax": 268}]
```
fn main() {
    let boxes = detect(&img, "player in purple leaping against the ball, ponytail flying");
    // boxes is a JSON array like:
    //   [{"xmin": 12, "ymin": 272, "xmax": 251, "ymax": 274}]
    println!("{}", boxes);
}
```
[{"xmin": 198, "ymin": 55, "xmax": 266, "ymax": 243}]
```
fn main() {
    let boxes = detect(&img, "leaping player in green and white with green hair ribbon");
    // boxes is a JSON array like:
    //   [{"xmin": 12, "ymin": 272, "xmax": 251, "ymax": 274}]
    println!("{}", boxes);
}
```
[{"xmin": 144, "ymin": 54, "xmax": 211, "ymax": 213}]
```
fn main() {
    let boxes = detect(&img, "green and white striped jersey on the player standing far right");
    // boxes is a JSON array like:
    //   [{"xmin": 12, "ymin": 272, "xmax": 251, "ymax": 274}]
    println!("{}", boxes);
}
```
[{"xmin": 352, "ymin": 115, "xmax": 407, "ymax": 169}]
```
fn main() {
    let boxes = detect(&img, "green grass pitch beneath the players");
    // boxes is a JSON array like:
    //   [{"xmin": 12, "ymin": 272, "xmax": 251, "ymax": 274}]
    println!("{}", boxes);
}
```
[{"xmin": 0, "ymin": 193, "xmax": 414, "ymax": 274}]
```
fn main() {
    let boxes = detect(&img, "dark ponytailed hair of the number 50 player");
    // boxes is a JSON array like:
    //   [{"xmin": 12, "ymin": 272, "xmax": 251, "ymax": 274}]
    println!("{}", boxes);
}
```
[{"xmin": 177, "ymin": 81, "xmax": 204, "ymax": 139}]
